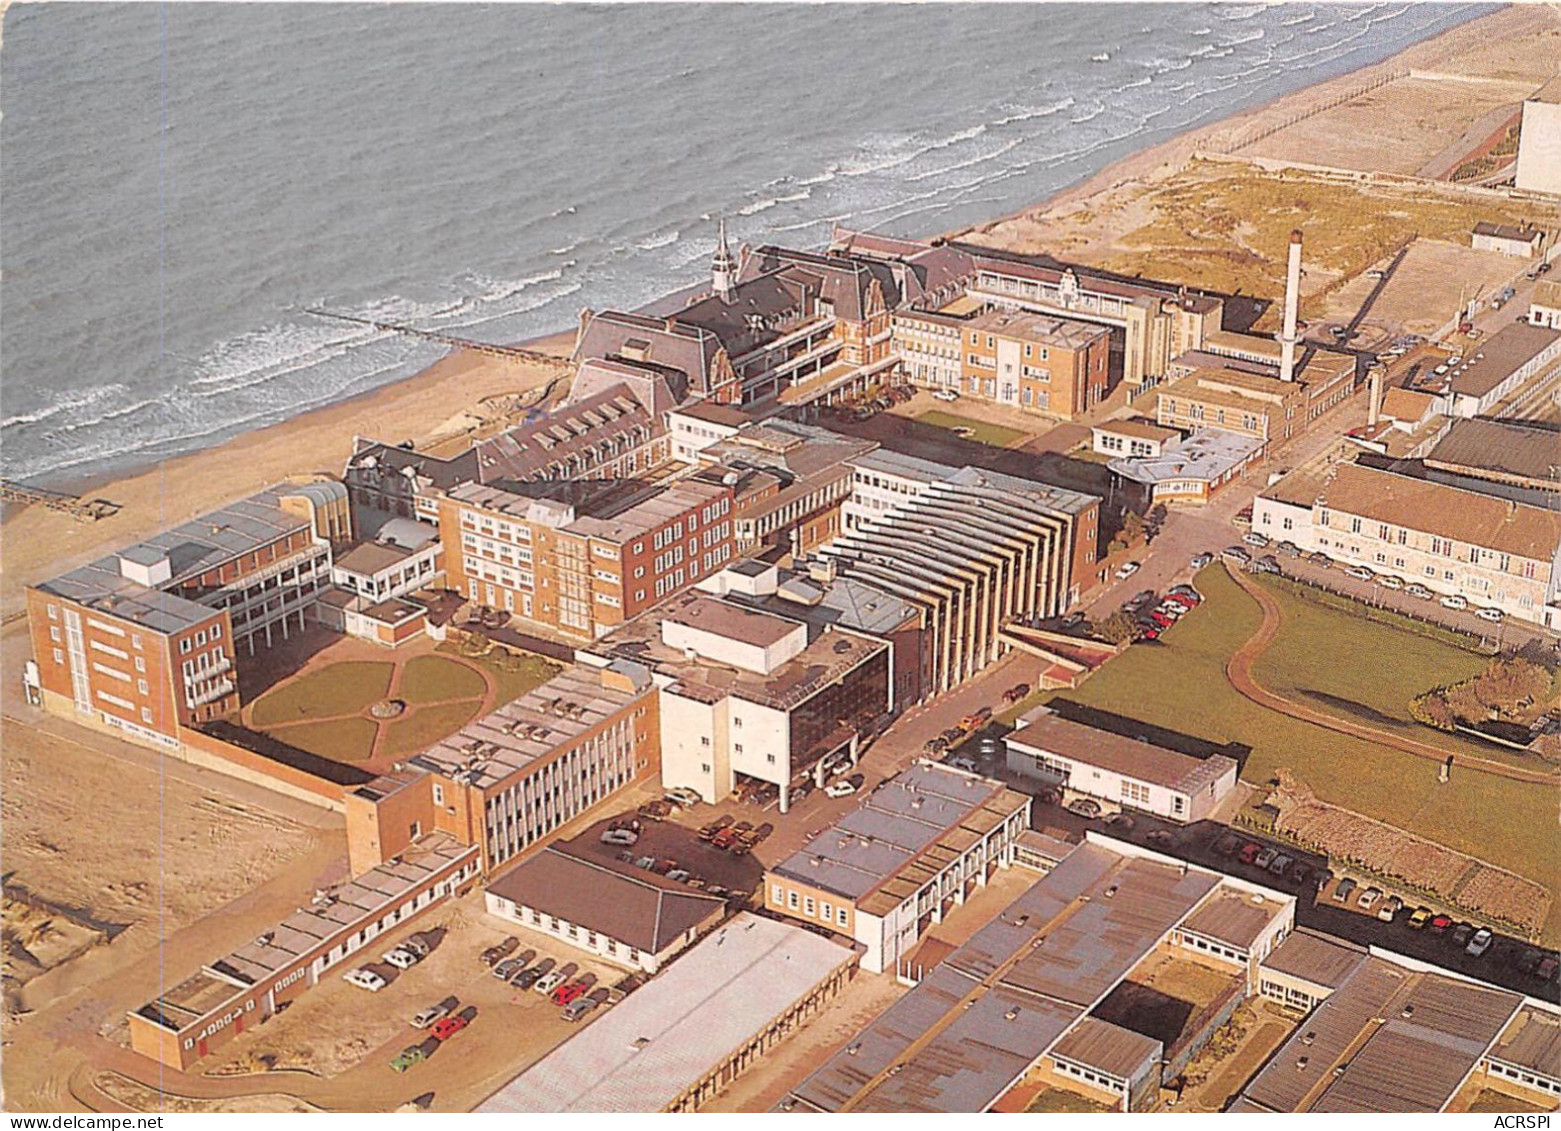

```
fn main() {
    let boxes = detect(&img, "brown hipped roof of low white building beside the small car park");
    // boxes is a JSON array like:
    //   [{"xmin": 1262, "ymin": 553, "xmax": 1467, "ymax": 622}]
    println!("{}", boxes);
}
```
[{"xmin": 487, "ymin": 844, "xmax": 726, "ymax": 955}]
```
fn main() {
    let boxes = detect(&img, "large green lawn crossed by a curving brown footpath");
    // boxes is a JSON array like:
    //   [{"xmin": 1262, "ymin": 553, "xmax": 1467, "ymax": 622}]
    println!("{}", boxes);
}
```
[{"xmin": 1058, "ymin": 565, "xmax": 1561, "ymax": 938}]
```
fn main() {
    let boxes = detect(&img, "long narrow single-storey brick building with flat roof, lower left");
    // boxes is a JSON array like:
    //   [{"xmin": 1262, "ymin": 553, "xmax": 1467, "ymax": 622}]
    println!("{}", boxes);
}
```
[{"xmin": 130, "ymin": 833, "xmax": 478, "ymax": 1072}]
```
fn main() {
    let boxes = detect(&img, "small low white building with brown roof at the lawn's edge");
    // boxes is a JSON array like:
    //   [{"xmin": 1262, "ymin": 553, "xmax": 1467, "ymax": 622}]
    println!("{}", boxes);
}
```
[{"xmin": 1005, "ymin": 707, "xmax": 1236, "ymax": 821}]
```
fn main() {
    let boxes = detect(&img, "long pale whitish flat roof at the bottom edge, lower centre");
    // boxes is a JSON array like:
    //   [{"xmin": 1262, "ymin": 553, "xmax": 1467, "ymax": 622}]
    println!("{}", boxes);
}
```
[{"xmin": 476, "ymin": 911, "xmax": 855, "ymax": 1114}]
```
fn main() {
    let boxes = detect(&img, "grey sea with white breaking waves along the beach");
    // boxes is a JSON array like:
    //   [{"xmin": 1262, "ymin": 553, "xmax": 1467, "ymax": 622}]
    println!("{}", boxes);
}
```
[{"xmin": 0, "ymin": 2, "xmax": 1491, "ymax": 485}]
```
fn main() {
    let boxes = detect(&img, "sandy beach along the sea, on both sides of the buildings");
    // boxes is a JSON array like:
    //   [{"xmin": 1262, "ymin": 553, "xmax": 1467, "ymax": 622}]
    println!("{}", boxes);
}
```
[{"xmin": 9, "ymin": 5, "xmax": 1561, "ymax": 616}]
